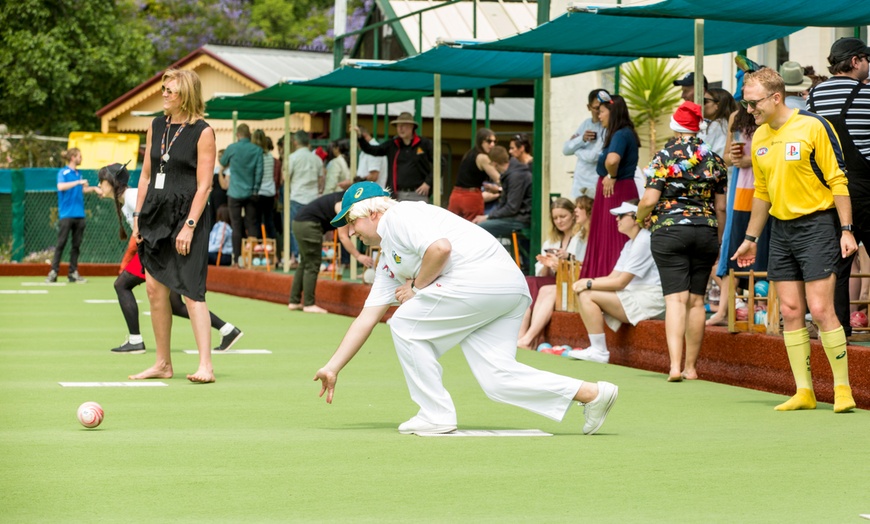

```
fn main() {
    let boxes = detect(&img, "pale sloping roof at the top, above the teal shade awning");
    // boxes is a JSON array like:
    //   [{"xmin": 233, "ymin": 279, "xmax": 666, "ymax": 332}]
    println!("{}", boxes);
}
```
[{"xmin": 390, "ymin": 0, "xmax": 538, "ymax": 52}]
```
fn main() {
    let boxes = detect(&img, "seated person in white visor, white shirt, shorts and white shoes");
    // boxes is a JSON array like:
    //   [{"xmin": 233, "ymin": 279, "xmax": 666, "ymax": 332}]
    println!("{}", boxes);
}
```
[{"xmin": 568, "ymin": 199, "xmax": 665, "ymax": 364}]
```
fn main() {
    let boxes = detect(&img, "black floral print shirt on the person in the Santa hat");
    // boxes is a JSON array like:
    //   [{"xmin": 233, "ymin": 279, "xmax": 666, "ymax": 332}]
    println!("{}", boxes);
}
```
[{"xmin": 646, "ymin": 136, "xmax": 728, "ymax": 232}]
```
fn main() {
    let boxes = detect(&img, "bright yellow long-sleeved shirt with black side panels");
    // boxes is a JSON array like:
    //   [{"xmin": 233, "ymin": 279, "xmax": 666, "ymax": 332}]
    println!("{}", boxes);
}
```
[{"xmin": 752, "ymin": 109, "xmax": 849, "ymax": 220}]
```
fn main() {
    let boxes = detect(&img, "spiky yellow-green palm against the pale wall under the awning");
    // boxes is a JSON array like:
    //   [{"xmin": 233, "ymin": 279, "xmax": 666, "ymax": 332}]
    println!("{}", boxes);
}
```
[{"xmin": 619, "ymin": 58, "xmax": 686, "ymax": 154}]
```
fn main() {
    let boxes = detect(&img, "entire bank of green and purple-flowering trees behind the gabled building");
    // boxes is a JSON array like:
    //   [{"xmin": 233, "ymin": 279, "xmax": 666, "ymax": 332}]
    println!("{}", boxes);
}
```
[{"xmin": 0, "ymin": 0, "xmax": 373, "ymax": 146}]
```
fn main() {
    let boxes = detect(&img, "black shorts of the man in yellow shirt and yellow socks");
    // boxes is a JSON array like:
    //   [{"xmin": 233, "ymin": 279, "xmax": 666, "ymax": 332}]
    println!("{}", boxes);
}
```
[{"xmin": 767, "ymin": 209, "xmax": 842, "ymax": 282}]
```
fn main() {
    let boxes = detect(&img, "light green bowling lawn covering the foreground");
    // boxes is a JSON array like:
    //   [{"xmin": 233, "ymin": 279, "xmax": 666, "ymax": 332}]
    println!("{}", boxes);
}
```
[{"xmin": 0, "ymin": 278, "xmax": 870, "ymax": 523}]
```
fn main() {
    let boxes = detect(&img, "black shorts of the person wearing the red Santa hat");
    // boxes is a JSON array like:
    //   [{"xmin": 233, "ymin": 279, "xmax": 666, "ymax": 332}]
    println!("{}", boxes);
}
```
[{"xmin": 650, "ymin": 226, "xmax": 719, "ymax": 296}]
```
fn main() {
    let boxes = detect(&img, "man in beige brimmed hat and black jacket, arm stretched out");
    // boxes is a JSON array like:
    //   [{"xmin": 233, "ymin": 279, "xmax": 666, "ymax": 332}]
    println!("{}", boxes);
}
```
[{"xmin": 357, "ymin": 111, "xmax": 432, "ymax": 202}]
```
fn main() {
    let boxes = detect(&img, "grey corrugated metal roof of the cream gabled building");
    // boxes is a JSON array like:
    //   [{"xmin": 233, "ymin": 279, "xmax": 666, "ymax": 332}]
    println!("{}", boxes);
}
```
[{"xmin": 203, "ymin": 44, "xmax": 334, "ymax": 86}]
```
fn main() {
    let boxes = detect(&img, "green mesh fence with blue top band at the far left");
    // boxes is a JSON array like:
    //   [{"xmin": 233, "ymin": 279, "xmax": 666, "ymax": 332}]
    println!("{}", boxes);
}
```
[{"xmin": 0, "ymin": 168, "xmax": 139, "ymax": 263}]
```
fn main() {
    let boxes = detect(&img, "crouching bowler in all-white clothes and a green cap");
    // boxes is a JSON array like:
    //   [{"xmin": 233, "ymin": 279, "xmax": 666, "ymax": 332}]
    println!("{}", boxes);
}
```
[{"xmin": 314, "ymin": 182, "xmax": 619, "ymax": 435}]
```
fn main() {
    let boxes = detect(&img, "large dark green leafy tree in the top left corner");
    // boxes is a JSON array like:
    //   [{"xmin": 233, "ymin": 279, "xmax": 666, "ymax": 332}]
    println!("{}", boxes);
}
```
[{"xmin": 0, "ymin": 0, "xmax": 153, "ymax": 135}]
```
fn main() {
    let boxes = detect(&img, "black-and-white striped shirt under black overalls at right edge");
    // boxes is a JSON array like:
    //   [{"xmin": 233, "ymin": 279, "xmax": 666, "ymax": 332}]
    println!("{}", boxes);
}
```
[{"xmin": 807, "ymin": 76, "xmax": 870, "ymax": 169}]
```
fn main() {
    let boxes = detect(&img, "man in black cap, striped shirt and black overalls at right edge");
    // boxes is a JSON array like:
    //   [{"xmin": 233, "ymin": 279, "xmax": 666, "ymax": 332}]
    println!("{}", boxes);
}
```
[{"xmin": 807, "ymin": 38, "xmax": 870, "ymax": 336}]
